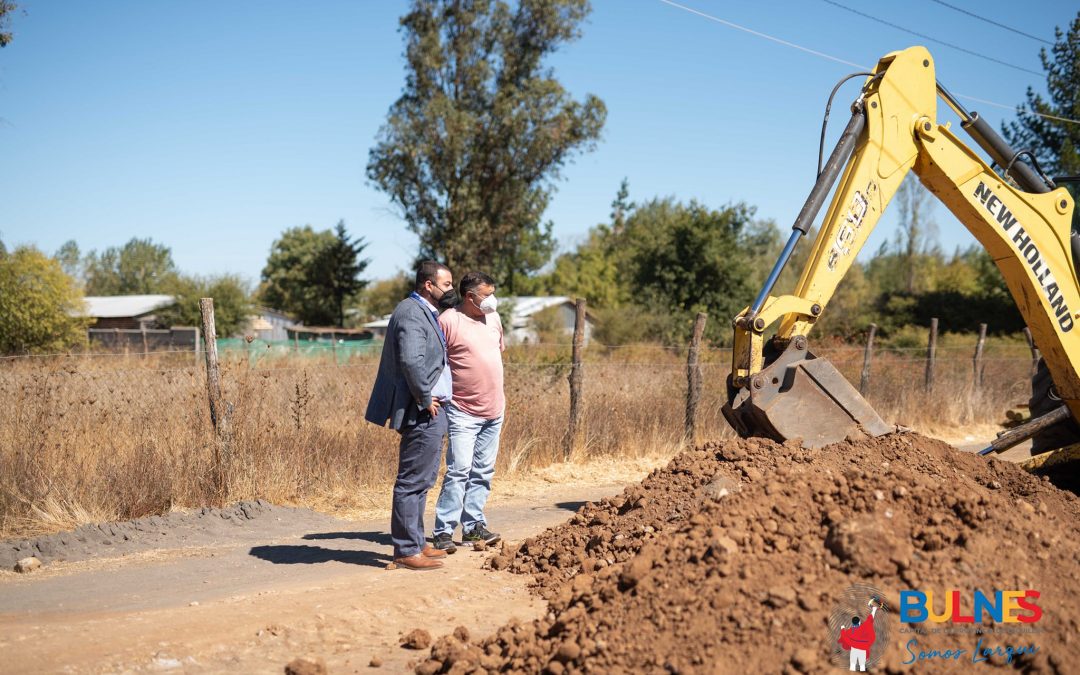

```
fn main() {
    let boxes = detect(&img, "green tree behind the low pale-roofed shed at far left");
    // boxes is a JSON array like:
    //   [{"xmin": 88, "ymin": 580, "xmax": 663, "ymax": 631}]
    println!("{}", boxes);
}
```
[{"xmin": 83, "ymin": 238, "xmax": 177, "ymax": 295}]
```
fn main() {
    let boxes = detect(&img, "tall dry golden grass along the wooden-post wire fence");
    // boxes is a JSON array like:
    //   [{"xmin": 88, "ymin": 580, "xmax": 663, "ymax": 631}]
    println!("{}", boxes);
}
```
[{"xmin": 0, "ymin": 336, "xmax": 1029, "ymax": 537}]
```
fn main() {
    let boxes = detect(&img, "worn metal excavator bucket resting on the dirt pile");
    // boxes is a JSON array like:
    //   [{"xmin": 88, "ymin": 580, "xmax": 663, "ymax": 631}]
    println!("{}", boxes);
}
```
[{"xmin": 724, "ymin": 338, "xmax": 895, "ymax": 448}]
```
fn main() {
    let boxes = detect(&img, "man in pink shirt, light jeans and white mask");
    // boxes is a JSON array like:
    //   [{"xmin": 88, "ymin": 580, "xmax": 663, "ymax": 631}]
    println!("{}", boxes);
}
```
[{"xmin": 432, "ymin": 272, "xmax": 507, "ymax": 553}]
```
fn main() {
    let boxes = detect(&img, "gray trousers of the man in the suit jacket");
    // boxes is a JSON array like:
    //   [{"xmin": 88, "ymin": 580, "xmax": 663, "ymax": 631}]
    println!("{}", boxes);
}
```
[{"xmin": 390, "ymin": 410, "xmax": 446, "ymax": 558}]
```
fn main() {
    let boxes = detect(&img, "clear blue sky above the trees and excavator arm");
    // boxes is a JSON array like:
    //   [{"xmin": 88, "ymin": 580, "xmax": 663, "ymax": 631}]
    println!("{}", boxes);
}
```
[{"xmin": 0, "ymin": 0, "xmax": 1076, "ymax": 282}]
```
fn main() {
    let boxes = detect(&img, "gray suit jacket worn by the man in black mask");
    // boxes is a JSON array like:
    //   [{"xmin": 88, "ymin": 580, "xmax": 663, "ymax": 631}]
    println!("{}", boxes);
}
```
[{"xmin": 364, "ymin": 297, "xmax": 446, "ymax": 430}]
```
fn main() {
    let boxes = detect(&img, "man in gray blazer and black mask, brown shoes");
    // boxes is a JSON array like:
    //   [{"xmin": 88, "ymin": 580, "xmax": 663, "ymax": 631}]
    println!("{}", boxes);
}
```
[{"xmin": 364, "ymin": 260, "xmax": 457, "ymax": 570}]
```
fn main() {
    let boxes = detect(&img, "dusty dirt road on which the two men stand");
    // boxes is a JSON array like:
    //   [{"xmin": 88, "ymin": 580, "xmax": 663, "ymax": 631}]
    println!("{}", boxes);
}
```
[{"xmin": 0, "ymin": 483, "xmax": 623, "ymax": 673}]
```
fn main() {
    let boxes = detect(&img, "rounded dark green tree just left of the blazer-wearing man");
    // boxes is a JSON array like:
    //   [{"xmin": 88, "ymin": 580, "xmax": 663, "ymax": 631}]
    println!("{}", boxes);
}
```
[{"xmin": 259, "ymin": 222, "xmax": 368, "ymax": 326}]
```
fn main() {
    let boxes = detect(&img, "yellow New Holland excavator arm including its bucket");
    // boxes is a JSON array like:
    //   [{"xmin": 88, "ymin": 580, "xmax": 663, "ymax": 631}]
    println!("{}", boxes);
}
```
[{"xmin": 724, "ymin": 46, "xmax": 1080, "ymax": 468}]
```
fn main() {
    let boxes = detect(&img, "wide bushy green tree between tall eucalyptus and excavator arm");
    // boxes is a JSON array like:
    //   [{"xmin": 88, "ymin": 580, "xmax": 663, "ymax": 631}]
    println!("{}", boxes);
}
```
[{"xmin": 537, "ymin": 192, "xmax": 764, "ymax": 343}]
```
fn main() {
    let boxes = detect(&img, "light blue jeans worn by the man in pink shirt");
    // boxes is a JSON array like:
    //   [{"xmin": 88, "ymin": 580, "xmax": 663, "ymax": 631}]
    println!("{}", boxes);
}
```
[{"xmin": 435, "ymin": 404, "xmax": 502, "ymax": 535}]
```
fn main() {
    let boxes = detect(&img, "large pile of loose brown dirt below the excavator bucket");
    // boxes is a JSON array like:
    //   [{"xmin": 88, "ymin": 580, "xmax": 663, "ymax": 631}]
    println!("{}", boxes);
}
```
[{"xmin": 417, "ymin": 434, "xmax": 1080, "ymax": 674}]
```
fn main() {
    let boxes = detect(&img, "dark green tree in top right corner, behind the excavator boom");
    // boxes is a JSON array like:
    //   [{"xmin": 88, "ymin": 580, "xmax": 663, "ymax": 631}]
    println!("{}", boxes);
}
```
[{"xmin": 1002, "ymin": 12, "xmax": 1080, "ymax": 176}]
